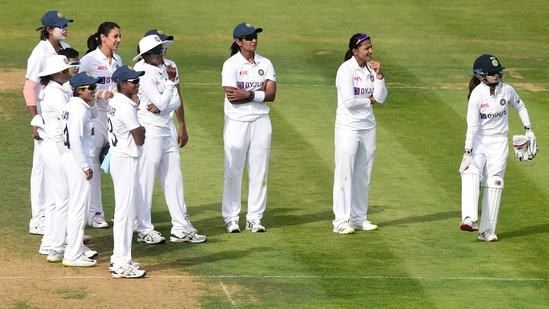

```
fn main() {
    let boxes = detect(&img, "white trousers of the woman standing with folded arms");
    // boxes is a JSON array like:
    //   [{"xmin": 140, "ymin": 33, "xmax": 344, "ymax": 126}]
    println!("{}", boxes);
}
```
[{"xmin": 221, "ymin": 115, "xmax": 272, "ymax": 223}]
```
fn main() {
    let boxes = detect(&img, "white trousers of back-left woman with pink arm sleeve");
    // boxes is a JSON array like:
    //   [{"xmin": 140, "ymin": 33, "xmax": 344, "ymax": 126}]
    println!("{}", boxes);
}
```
[{"xmin": 29, "ymin": 140, "xmax": 46, "ymax": 228}]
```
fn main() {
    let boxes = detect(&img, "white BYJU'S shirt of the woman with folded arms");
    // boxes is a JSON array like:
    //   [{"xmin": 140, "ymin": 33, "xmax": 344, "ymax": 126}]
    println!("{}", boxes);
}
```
[{"xmin": 221, "ymin": 52, "xmax": 276, "ymax": 121}]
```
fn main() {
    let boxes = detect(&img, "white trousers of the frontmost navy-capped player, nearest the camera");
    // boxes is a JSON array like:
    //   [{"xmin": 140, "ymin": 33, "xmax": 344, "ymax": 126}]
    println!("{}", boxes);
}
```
[{"xmin": 110, "ymin": 155, "xmax": 141, "ymax": 269}]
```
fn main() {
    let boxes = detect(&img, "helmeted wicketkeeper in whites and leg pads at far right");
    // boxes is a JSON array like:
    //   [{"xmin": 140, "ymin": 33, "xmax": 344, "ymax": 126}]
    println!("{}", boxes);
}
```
[{"xmin": 459, "ymin": 54, "xmax": 536, "ymax": 242}]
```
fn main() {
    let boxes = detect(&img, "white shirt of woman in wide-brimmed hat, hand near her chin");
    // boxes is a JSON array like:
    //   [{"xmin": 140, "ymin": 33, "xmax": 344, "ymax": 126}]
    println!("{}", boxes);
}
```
[{"xmin": 134, "ymin": 60, "xmax": 180, "ymax": 137}]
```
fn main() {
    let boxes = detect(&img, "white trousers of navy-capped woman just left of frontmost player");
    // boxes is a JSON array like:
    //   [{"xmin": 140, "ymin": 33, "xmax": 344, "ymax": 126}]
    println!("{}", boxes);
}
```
[{"xmin": 61, "ymin": 151, "xmax": 95, "ymax": 261}]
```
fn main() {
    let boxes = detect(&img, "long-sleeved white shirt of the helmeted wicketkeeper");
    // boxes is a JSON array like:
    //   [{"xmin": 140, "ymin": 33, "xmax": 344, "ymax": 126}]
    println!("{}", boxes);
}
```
[{"xmin": 465, "ymin": 83, "xmax": 530, "ymax": 149}]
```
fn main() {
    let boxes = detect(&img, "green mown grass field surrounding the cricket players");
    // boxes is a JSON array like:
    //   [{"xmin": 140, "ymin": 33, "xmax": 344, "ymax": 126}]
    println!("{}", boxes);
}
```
[{"xmin": 0, "ymin": 0, "xmax": 549, "ymax": 308}]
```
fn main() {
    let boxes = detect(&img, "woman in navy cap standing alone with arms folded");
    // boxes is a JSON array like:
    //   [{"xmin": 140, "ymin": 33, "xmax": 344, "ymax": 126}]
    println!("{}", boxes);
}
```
[{"xmin": 221, "ymin": 23, "xmax": 276, "ymax": 233}]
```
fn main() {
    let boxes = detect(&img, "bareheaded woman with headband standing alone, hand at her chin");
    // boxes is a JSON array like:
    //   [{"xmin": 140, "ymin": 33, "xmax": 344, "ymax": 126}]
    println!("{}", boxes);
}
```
[{"xmin": 332, "ymin": 33, "xmax": 387, "ymax": 235}]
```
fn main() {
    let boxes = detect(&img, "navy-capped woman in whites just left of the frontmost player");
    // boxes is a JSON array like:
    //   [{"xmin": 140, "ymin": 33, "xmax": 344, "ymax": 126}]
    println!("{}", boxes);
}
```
[{"xmin": 61, "ymin": 72, "xmax": 99, "ymax": 267}]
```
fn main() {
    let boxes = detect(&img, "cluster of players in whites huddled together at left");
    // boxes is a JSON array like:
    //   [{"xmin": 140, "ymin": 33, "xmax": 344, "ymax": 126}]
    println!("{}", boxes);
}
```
[{"xmin": 23, "ymin": 11, "xmax": 207, "ymax": 278}]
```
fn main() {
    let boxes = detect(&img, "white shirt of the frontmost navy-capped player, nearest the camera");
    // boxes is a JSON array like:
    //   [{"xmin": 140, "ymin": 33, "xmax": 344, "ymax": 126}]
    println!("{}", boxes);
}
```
[{"xmin": 107, "ymin": 93, "xmax": 141, "ymax": 158}]
